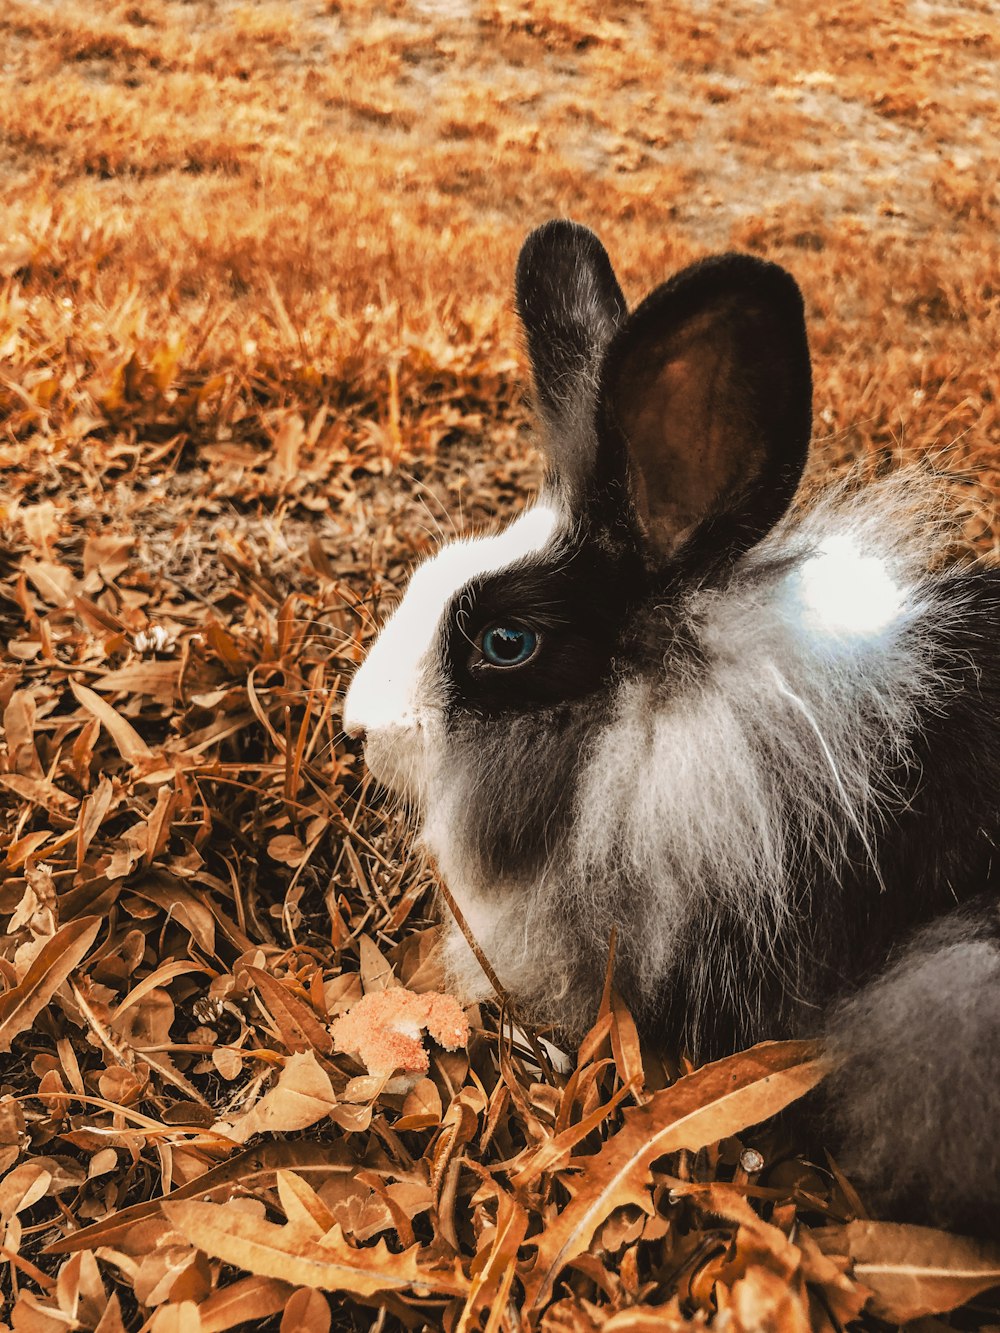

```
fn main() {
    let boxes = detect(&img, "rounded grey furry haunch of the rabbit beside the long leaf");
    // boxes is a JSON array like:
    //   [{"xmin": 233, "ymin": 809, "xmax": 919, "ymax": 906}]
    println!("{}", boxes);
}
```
[{"xmin": 827, "ymin": 906, "xmax": 1000, "ymax": 1234}]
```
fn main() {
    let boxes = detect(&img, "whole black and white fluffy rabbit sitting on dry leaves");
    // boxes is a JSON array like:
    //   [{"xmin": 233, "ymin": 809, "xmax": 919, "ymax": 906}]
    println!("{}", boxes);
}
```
[{"xmin": 344, "ymin": 221, "xmax": 1000, "ymax": 1230}]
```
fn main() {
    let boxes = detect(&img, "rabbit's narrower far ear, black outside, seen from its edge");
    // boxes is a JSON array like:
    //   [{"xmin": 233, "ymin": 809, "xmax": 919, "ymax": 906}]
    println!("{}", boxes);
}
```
[{"xmin": 515, "ymin": 220, "xmax": 627, "ymax": 497}]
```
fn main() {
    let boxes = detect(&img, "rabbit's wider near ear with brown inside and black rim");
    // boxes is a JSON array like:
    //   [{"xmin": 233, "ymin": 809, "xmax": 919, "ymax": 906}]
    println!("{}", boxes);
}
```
[{"xmin": 597, "ymin": 255, "xmax": 812, "ymax": 563}]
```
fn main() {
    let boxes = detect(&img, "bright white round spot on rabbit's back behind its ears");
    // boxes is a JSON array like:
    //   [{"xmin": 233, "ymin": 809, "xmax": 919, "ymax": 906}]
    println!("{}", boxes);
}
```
[{"xmin": 799, "ymin": 535, "xmax": 905, "ymax": 639}]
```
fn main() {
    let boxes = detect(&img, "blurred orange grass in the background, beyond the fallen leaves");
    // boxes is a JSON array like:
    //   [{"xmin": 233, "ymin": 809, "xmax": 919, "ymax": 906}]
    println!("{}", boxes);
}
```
[{"xmin": 0, "ymin": 0, "xmax": 1000, "ymax": 544}]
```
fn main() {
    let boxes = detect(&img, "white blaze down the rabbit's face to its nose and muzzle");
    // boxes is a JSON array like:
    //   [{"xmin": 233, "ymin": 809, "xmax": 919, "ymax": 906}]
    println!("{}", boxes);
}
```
[{"xmin": 344, "ymin": 504, "xmax": 563, "ymax": 796}]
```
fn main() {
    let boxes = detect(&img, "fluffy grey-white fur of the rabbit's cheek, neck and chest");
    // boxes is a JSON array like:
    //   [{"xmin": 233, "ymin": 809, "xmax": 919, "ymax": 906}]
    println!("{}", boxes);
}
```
[{"xmin": 423, "ymin": 477, "xmax": 989, "ymax": 1050}]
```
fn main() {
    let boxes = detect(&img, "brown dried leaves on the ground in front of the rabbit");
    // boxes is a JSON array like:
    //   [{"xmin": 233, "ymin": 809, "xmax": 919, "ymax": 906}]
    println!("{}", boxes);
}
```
[{"xmin": 0, "ymin": 341, "xmax": 1000, "ymax": 1333}]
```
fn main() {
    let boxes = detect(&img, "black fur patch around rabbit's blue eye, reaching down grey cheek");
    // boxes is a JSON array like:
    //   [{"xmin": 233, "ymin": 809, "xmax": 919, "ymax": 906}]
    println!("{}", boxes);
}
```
[{"xmin": 444, "ymin": 525, "xmax": 645, "ymax": 880}]
